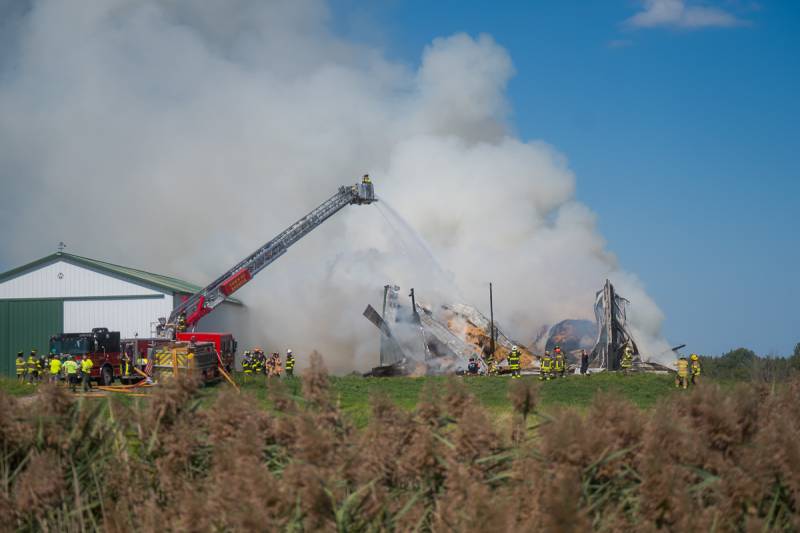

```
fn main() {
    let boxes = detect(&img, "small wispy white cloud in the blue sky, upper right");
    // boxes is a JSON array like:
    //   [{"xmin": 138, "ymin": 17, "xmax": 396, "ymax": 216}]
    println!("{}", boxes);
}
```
[{"xmin": 625, "ymin": 0, "xmax": 746, "ymax": 29}]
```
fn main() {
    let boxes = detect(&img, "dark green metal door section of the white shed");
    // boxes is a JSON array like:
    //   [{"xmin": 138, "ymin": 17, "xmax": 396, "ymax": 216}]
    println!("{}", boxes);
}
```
[{"xmin": 0, "ymin": 300, "xmax": 64, "ymax": 376}]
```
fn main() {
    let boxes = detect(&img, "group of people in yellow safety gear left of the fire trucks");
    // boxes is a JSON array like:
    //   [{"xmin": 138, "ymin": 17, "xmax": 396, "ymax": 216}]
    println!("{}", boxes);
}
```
[{"xmin": 16, "ymin": 349, "xmax": 94, "ymax": 392}]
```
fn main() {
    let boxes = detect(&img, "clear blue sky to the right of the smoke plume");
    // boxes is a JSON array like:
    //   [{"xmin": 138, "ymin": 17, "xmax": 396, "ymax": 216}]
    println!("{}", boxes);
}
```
[{"xmin": 333, "ymin": 0, "xmax": 800, "ymax": 354}]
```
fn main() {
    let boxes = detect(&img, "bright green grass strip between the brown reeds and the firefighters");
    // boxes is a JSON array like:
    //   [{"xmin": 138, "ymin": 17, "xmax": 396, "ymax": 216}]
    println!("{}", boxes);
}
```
[{"xmin": 0, "ymin": 373, "xmax": 676, "ymax": 426}]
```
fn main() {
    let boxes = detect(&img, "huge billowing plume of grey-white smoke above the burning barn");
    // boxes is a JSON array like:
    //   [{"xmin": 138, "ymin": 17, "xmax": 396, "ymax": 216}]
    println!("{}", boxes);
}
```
[{"xmin": 0, "ymin": 0, "xmax": 666, "ymax": 371}]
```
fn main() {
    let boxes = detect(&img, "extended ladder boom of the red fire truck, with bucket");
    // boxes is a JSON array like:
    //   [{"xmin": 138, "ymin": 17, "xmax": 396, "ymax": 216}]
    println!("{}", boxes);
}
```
[{"xmin": 168, "ymin": 176, "xmax": 376, "ymax": 328}]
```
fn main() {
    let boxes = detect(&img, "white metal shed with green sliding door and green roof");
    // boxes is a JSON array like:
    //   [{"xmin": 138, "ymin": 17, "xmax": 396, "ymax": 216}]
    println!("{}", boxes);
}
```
[{"xmin": 0, "ymin": 252, "xmax": 240, "ymax": 374}]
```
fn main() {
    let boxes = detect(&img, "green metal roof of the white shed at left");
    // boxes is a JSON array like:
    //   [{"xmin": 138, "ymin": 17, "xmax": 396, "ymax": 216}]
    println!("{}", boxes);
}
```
[{"xmin": 0, "ymin": 252, "xmax": 241, "ymax": 305}]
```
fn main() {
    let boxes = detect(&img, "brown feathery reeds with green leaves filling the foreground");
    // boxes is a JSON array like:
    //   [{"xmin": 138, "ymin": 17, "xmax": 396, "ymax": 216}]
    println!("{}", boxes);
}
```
[{"xmin": 0, "ymin": 356, "xmax": 800, "ymax": 532}]
